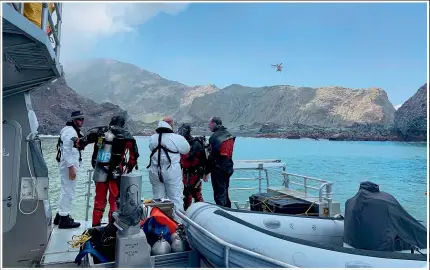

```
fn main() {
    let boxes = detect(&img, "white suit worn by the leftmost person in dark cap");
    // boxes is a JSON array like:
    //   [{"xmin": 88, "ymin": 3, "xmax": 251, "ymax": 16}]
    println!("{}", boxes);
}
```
[{"xmin": 58, "ymin": 126, "xmax": 80, "ymax": 216}]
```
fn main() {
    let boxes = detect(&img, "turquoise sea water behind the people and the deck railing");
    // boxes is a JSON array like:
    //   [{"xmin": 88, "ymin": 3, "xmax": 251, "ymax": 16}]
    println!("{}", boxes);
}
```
[{"xmin": 42, "ymin": 137, "xmax": 427, "ymax": 223}]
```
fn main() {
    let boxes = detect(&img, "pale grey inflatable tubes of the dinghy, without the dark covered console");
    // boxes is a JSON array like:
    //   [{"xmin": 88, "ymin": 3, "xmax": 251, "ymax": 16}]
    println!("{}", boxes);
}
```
[{"xmin": 184, "ymin": 203, "xmax": 427, "ymax": 268}]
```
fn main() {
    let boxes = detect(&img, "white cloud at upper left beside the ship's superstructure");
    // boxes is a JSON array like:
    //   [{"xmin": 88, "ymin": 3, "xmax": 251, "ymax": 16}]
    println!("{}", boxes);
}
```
[{"xmin": 54, "ymin": 2, "xmax": 188, "ymax": 58}]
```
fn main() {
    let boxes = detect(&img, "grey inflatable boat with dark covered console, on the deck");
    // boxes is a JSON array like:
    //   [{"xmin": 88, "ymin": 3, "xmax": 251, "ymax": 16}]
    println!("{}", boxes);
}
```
[{"xmin": 184, "ymin": 181, "xmax": 427, "ymax": 268}]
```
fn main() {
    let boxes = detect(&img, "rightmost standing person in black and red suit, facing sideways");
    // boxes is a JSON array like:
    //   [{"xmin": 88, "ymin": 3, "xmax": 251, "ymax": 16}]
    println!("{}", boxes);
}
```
[{"xmin": 203, "ymin": 116, "xmax": 236, "ymax": 208}]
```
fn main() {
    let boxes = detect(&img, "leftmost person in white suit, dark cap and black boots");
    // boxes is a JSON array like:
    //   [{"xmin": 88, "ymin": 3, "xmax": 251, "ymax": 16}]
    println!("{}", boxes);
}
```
[{"xmin": 54, "ymin": 111, "xmax": 84, "ymax": 229}]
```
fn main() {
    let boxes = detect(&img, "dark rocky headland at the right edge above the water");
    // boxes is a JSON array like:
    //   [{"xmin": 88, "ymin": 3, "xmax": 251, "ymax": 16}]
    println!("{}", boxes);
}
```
[{"xmin": 394, "ymin": 83, "xmax": 428, "ymax": 141}]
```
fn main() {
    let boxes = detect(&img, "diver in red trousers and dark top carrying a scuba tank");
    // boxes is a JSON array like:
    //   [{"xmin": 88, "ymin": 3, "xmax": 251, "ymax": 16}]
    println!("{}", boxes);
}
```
[{"xmin": 91, "ymin": 116, "xmax": 139, "ymax": 227}]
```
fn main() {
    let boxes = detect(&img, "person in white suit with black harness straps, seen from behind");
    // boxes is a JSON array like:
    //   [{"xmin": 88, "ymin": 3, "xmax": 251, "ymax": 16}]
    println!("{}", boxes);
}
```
[{"xmin": 148, "ymin": 121, "xmax": 190, "ymax": 214}]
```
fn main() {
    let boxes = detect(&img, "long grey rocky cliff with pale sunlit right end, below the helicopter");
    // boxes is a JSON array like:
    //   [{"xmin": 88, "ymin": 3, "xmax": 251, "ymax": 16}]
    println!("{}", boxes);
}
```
[{"xmin": 181, "ymin": 85, "xmax": 395, "ymax": 128}]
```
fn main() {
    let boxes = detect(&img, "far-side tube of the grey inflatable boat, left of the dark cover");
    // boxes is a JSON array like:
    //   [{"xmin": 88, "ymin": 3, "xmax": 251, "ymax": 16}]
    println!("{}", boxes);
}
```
[{"xmin": 187, "ymin": 202, "xmax": 344, "ymax": 246}]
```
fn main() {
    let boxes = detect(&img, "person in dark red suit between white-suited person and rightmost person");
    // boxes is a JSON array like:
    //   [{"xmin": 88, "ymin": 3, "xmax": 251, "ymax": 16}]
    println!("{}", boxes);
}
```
[{"xmin": 178, "ymin": 123, "xmax": 207, "ymax": 210}]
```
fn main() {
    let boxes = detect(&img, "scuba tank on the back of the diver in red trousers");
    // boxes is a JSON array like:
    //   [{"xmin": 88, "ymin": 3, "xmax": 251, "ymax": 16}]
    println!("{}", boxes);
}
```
[{"xmin": 93, "ymin": 129, "xmax": 115, "ymax": 182}]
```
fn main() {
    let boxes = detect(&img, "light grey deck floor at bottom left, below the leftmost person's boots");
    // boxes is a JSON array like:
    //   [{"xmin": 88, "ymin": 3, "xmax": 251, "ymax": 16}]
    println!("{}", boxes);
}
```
[{"xmin": 40, "ymin": 220, "xmax": 106, "ymax": 268}]
